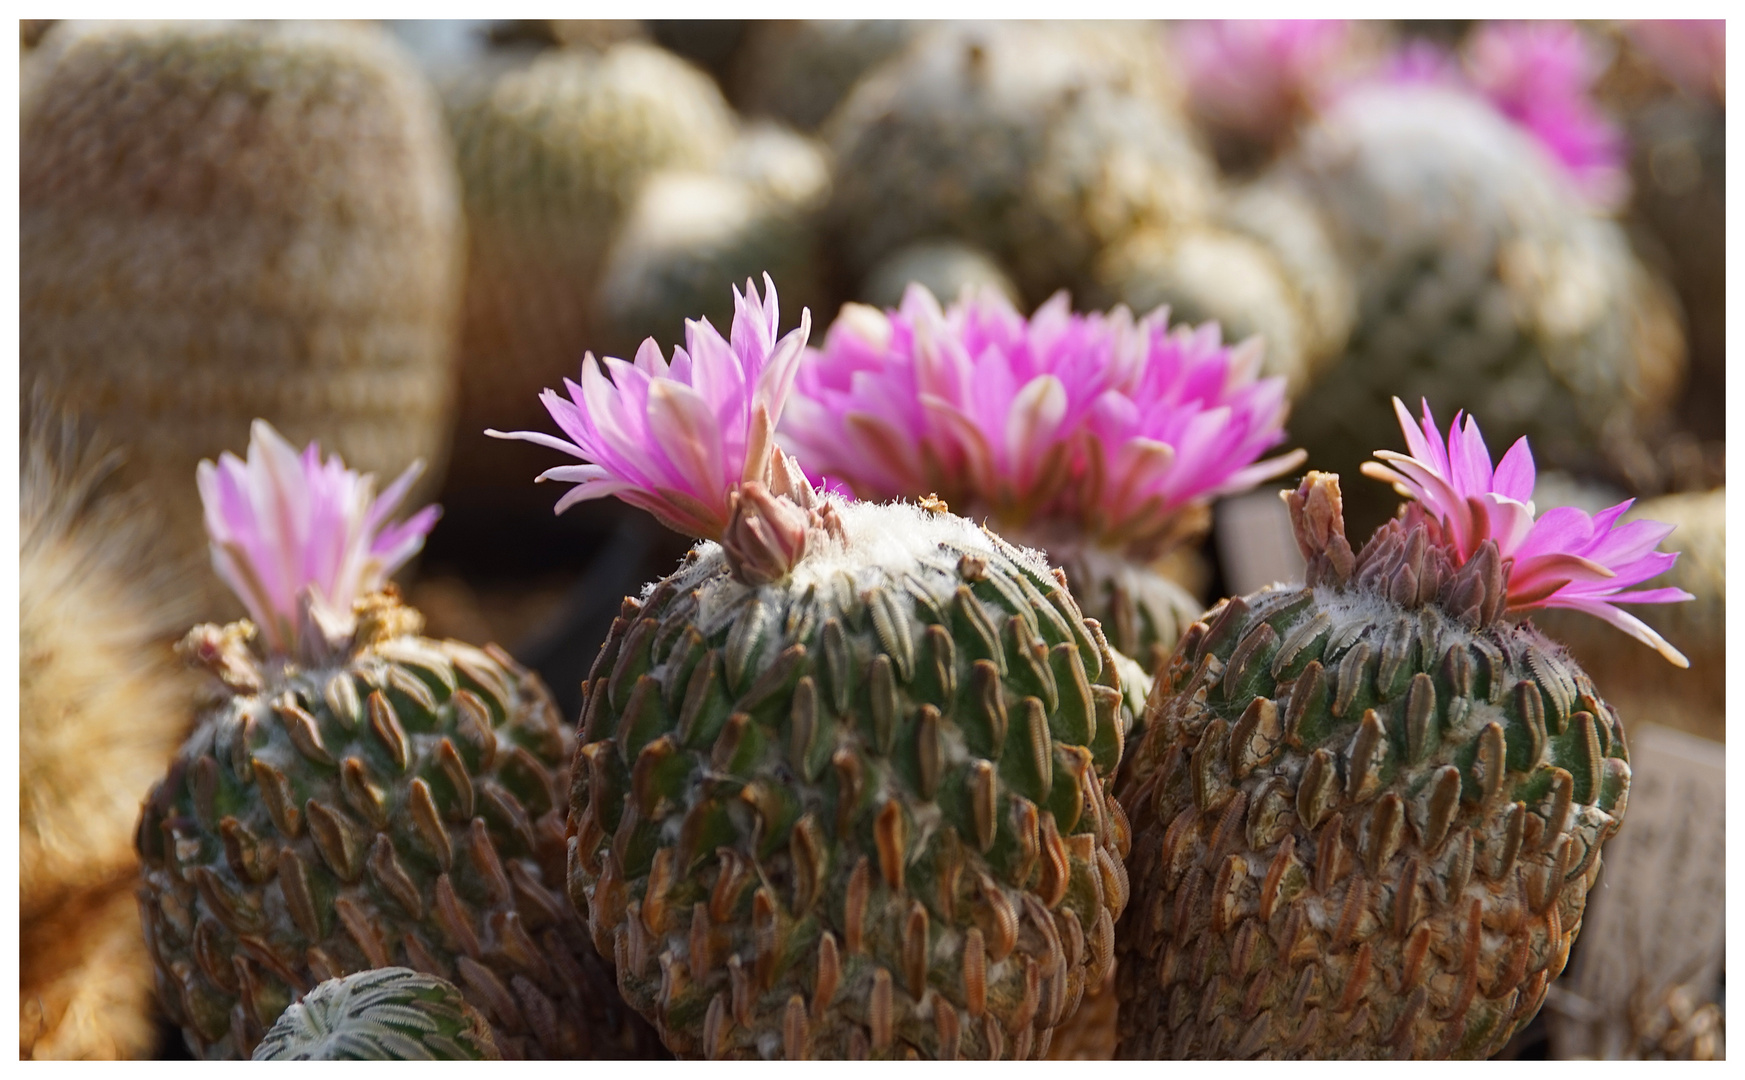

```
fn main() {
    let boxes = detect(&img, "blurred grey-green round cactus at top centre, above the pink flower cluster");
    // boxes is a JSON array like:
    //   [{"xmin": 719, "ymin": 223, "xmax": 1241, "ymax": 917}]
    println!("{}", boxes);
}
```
[{"xmin": 827, "ymin": 23, "xmax": 1213, "ymax": 304}]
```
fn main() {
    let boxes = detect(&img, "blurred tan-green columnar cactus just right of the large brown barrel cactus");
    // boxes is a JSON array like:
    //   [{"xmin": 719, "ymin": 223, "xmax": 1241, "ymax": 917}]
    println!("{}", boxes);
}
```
[{"xmin": 443, "ymin": 42, "xmax": 735, "ymax": 490}]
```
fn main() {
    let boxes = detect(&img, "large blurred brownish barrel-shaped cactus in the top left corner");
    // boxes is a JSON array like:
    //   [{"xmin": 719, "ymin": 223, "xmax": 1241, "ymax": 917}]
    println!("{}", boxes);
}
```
[{"xmin": 19, "ymin": 23, "xmax": 461, "ymax": 617}]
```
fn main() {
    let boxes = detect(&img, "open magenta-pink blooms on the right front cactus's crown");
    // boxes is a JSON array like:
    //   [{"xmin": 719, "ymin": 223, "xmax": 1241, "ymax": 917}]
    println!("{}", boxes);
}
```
[{"xmin": 1363, "ymin": 398, "xmax": 1691, "ymax": 668}]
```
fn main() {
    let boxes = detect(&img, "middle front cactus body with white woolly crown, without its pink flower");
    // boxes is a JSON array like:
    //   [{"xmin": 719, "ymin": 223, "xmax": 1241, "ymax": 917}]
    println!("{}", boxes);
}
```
[{"xmin": 569, "ymin": 504, "xmax": 1127, "ymax": 1059}]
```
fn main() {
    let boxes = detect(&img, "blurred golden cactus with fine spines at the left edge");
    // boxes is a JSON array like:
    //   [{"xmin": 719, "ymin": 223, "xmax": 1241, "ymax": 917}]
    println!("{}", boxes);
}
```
[{"xmin": 17, "ymin": 412, "xmax": 187, "ymax": 1057}]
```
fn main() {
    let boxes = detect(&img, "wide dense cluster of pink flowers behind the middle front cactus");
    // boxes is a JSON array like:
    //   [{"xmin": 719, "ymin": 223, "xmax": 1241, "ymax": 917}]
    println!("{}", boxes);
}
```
[{"xmin": 782, "ymin": 286, "xmax": 1302, "ymax": 558}]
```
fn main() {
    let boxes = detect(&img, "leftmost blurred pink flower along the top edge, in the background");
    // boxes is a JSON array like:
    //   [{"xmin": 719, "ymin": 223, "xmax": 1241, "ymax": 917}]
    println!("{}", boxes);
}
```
[{"xmin": 1171, "ymin": 19, "xmax": 1352, "ymax": 138}]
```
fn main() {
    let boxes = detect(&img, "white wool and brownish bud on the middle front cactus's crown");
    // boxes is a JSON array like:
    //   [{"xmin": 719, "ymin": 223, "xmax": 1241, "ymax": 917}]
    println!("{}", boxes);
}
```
[{"xmin": 642, "ymin": 496, "xmax": 1052, "ymax": 633}]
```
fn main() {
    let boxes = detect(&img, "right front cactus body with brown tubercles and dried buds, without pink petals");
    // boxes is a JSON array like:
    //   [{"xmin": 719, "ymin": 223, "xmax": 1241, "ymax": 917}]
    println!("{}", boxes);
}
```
[{"xmin": 1117, "ymin": 495, "xmax": 1630, "ymax": 1059}]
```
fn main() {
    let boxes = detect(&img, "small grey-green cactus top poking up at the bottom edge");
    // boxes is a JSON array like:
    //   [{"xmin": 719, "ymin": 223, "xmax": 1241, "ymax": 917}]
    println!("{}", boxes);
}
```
[{"xmin": 255, "ymin": 968, "xmax": 503, "ymax": 1061}]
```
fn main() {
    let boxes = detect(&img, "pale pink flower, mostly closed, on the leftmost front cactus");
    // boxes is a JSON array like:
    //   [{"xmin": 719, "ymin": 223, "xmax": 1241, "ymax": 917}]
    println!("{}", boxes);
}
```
[{"xmin": 195, "ymin": 420, "xmax": 441, "ymax": 653}]
